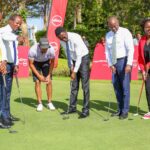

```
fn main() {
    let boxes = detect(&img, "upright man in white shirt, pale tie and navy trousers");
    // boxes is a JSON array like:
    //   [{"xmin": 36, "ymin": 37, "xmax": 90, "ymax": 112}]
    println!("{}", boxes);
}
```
[{"xmin": 106, "ymin": 16, "xmax": 134, "ymax": 119}]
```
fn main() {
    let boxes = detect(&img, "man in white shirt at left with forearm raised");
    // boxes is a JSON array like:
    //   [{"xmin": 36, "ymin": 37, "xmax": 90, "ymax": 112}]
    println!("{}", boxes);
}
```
[{"xmin": 0, "ymin": 14, "xmax": 24, "ymax": 126}]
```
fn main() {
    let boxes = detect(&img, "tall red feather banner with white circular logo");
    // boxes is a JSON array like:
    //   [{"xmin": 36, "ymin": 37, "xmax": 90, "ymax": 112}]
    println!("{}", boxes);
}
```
[{"xmin": 47, "ymin": 0, "xmax": 68, "ymax": 67}]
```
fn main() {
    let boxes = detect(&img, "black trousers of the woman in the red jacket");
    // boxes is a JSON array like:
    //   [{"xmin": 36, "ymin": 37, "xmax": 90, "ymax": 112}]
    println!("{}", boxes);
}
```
[{"xmin": 145, "ymin": 73, "xmax": 150, "ymax": 112}]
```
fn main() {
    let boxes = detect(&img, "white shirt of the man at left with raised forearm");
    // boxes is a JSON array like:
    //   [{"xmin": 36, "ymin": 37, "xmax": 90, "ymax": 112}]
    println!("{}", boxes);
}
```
[{"xmin": 0, "ymin": 24, "xmax": 19, "ymax": 65}]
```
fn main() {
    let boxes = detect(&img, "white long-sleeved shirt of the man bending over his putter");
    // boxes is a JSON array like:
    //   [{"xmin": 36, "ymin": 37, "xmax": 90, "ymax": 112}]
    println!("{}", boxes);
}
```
[{"xmin": 61, "ymin": 32, "xmax": 89, "ymax": 72}]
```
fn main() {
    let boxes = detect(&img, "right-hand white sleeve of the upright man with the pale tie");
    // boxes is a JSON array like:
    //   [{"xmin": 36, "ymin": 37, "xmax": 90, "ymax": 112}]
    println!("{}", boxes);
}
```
[{"xmin": 125, "ymin": 30, "xmax": 134, "ymax": 66}]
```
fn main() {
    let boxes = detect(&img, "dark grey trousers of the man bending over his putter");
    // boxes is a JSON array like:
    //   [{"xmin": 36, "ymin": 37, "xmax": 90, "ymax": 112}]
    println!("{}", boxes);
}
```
[{"xmin": 69, "ymin": 55, "xmax": 90, "ymax": 114}]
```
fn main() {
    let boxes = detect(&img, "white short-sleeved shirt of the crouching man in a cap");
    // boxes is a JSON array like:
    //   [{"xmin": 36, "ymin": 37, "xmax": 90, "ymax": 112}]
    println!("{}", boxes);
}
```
[{"xmin": 28, "ymin": 43, "xmax": 55, "ymax": 62}]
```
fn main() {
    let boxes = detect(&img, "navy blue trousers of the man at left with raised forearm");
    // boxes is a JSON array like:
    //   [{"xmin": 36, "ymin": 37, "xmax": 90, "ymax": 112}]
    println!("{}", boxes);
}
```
[{"xmin": 0, "ymin": 64, "xmax": 14, "ymax": 118}]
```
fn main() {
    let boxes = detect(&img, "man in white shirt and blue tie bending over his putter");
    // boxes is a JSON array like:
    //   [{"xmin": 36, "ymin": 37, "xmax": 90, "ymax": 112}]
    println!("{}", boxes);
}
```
[{"xmin": 55, "ymin": 27, "xmax": 90, "ymax": 118}]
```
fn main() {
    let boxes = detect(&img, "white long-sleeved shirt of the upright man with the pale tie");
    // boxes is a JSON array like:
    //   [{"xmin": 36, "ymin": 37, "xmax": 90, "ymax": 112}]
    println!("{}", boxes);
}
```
[{"xmin": 105, "ymin": 27, "xmax": 134, "ymax": 66}]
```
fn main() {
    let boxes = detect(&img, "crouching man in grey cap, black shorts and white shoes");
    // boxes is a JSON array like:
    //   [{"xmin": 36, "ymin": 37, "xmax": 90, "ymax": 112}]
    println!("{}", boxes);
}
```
[{"xmin": 28, "ymin": 38, "xmax": 55, "ymax": 111}]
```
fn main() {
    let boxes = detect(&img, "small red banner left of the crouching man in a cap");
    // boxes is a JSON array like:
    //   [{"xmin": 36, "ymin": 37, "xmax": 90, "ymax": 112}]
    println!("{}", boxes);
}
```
[{"xmin": 18, "ymin": 46, "xmax": 29, "ymax": 78}]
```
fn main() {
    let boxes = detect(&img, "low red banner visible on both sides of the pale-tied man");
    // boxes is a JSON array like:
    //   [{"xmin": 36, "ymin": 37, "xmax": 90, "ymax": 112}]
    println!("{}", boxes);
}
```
[{"xmin": 90, "ymin": 44, "xmax": 138, "ymax": 80}]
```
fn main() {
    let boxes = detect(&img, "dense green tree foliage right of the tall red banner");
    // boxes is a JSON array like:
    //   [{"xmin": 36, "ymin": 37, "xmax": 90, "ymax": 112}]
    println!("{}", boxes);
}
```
[{"xmin": 65, "ymin": 0, "xmax": 150, "ymax": 59}]
